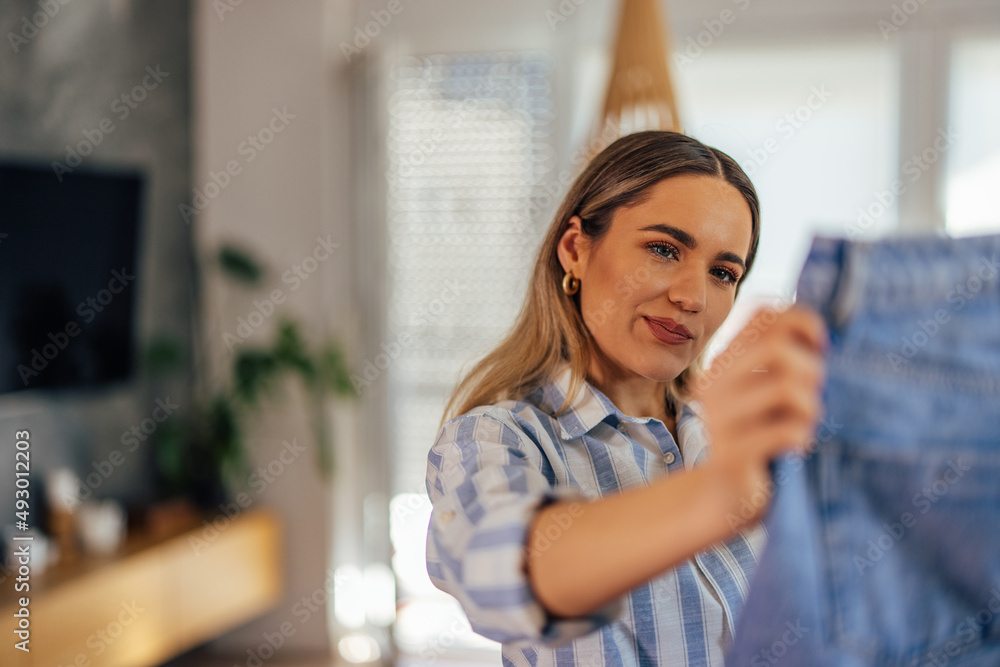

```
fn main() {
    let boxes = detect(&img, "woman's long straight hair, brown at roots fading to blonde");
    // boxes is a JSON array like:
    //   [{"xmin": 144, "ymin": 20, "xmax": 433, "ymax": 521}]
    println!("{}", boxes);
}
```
[{"xmin": 439, "ymin": 130, "xmax": 760, "ymax": 428}]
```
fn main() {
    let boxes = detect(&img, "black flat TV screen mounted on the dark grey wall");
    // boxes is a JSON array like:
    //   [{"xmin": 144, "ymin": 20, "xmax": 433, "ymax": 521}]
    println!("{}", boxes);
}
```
[{"xmin": 0, "ymin": 161, "xmax": 144, "ymax": 393}]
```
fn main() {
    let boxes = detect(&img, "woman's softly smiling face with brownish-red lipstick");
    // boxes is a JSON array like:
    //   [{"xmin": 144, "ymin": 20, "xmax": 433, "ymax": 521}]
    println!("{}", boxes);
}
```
[{"xmin": 558, "ymin": 174, "xmax": 752, "ymax": 382}]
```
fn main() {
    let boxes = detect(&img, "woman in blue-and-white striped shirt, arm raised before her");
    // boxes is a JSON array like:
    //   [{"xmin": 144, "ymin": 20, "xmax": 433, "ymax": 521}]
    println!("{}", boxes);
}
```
[{"xmin": 427, "ymin": 131, "xmax": 826, "ymax": 667}]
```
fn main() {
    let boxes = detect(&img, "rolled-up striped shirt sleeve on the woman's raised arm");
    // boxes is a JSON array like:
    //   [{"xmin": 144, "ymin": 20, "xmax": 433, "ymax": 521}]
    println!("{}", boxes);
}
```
[{"xmin": 426, "ymin": 414, "xmax": 625, "ymax": 647}]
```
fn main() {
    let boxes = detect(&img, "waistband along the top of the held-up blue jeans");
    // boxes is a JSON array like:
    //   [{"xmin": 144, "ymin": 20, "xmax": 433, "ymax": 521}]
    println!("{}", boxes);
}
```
[{"xmin": 796, "ymin": 234, "xmax": 1000, "ymax": 330}]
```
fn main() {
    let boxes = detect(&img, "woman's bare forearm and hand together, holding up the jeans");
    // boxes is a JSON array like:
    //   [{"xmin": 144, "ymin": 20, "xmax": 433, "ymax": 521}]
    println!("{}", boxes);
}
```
[{"xmin": 527, "ymin": 308, "xmax": 826, "ymax": 618}]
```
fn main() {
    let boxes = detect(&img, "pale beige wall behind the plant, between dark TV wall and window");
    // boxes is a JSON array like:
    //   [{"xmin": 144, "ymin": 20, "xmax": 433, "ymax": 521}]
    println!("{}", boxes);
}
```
[{"xmin": 189, "ymin": 0, "xmax": 352, "ymax": 658}]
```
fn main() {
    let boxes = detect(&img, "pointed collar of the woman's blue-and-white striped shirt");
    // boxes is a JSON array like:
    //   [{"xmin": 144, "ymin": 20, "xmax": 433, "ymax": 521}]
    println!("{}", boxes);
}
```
[{"xmin": 536, "ymin": 362, "xmax": 701, "ymax": 440}]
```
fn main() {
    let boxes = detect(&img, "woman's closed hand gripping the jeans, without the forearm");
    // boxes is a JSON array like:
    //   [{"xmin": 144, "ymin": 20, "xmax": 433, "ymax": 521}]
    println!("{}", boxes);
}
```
[{"xmin": 692, "ymin": 307, "xmax": 827, "ymax": 527}]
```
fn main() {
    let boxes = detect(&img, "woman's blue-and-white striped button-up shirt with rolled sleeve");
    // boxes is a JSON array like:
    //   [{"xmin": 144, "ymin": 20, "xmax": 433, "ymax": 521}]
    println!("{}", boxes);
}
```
[{"xmin": 427, "ymin": 364, "xmax": 765, "ymax": 667}]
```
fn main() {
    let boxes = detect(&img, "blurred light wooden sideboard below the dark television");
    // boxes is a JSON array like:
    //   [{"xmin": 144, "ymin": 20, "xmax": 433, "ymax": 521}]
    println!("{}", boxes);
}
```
[{"xmin": 0, "ymin": 509, "xmax": 284, "ymax": 667}]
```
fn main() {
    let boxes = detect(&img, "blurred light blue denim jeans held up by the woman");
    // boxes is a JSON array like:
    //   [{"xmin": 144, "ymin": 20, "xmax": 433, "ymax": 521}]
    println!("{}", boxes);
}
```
[{"xmin": 726, "ymin": 235, "xmax": 1000, "ymax": 667}]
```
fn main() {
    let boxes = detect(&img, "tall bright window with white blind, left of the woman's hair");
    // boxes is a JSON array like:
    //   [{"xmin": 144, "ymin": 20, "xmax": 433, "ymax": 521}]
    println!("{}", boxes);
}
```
[{"xmin": 388, "ymin": 53, "xmax": 555, "ymax": 659}]
